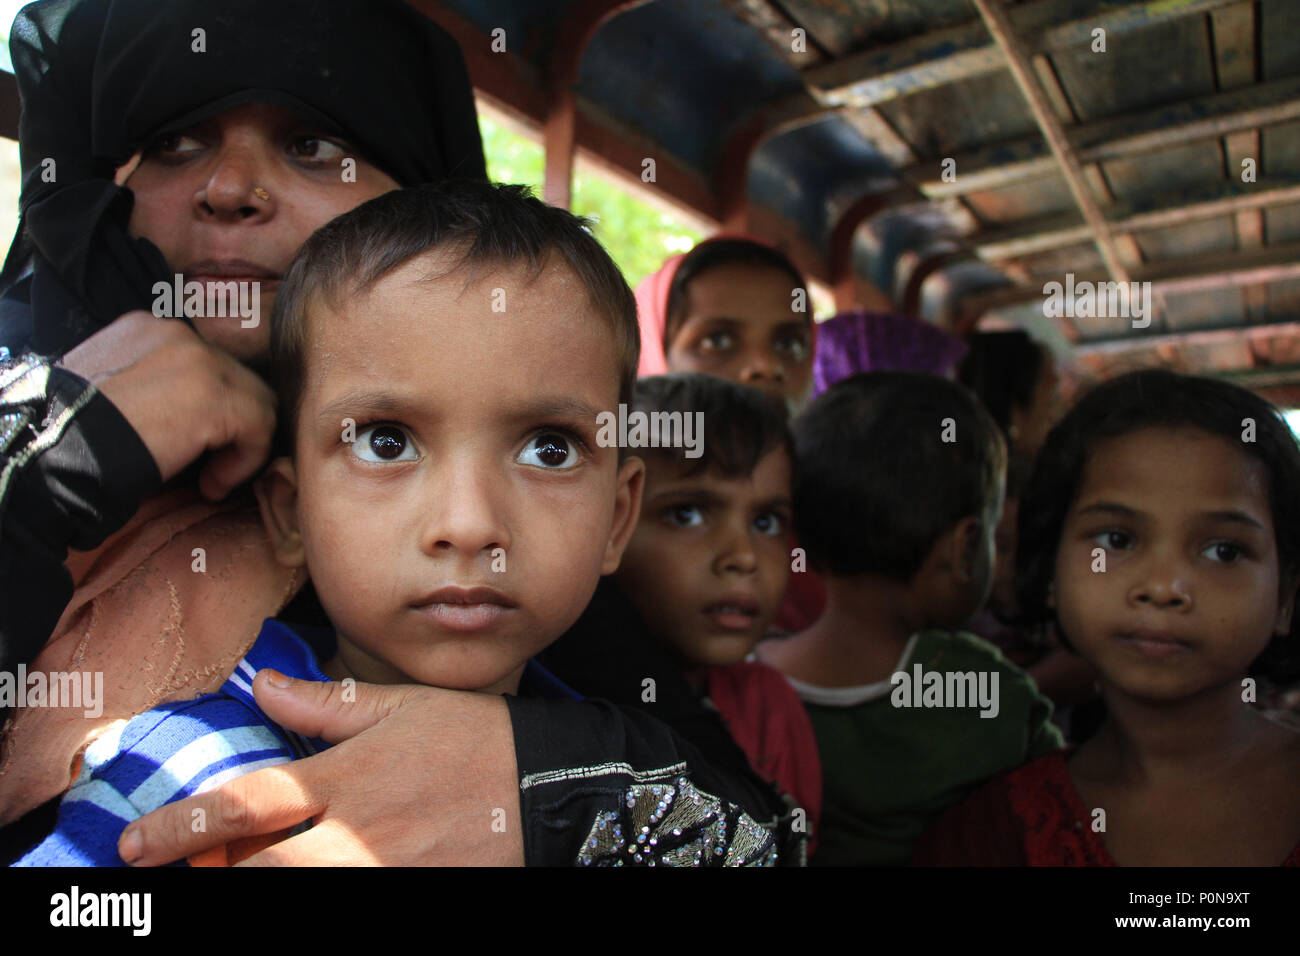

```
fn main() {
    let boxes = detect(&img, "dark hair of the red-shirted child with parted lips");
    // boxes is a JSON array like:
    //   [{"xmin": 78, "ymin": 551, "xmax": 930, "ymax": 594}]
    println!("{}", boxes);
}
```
[{"xmin": 632, "ymin": 372, "xmax": 796, "ymax": 479}]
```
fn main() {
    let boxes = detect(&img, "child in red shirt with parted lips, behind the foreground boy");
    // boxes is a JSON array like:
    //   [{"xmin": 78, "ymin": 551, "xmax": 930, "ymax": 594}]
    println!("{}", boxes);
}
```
[{"xmin": 603, "ymin": 373, "xmax": 822, "ymax": 842}]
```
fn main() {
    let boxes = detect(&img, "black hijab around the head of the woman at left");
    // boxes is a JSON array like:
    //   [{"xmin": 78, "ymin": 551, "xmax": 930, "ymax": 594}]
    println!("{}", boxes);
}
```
[{"xmin": 0, "ymin": 0, "xmax": 486, "ymax": 355}]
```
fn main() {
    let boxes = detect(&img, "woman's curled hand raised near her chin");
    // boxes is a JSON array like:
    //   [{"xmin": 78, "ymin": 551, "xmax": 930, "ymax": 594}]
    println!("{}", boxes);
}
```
[{"xmin": 59, "ymin": 311, "xmax": 276, "ymax": 501}]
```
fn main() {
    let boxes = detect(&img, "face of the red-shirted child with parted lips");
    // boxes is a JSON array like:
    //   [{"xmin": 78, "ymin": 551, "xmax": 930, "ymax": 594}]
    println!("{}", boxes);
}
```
[{"xmin": 619, "ymin": 449, "xmax": 790, "ymax": 666}]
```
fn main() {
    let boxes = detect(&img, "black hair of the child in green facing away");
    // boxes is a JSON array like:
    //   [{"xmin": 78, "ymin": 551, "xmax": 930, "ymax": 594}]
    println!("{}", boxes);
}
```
[{"xmin": 794, "ymin": 372, "xmax": 1006, "ymax": 581}]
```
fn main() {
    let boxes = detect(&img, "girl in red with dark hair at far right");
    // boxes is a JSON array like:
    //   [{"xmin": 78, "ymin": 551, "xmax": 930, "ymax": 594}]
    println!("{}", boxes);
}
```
[{"xmin": 915, "ymin": 371, "xmax": 1300, "ymax": 866}]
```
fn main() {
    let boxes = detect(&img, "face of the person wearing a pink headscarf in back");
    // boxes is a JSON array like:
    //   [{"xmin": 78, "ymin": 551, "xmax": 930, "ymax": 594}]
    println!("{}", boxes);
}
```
[{"xmin": 666, "ymin": 265, "xmax": 813, "ymax": 401}]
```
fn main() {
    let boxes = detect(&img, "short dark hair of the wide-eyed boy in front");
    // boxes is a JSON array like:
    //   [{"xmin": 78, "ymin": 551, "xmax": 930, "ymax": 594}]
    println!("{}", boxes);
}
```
[{"xmin": 270, "ymin": 179, "xmax": 641, "ymax": 447}]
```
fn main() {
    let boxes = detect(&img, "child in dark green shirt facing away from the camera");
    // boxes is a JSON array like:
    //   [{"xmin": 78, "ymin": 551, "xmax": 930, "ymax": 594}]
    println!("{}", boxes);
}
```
[{"xmin": 758, "ymin": 372, "xmax": 1062, "ymax": 865}]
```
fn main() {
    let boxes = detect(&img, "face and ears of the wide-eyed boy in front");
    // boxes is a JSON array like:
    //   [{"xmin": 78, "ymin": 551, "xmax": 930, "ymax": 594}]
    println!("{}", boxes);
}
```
[{"xmin": 260, "ymin": 252, "xmax": 642, "ymax": 692}]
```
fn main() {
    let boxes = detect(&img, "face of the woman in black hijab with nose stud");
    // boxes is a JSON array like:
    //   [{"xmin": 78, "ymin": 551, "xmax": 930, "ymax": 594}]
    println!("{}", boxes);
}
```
[{"xmin": 128, "ymin": 104, "xmax": 398, "ymax": 362}]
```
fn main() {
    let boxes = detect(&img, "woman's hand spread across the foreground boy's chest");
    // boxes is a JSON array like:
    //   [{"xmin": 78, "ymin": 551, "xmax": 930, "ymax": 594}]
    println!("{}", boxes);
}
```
[{"xmin": 118, "ymin": 670, "xmax": 524, "ymax": 866}]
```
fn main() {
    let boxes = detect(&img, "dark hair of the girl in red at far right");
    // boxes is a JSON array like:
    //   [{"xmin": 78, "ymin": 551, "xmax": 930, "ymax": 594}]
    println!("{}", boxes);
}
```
[{"xmin": 1015, "ymin": 369, "xmax": 1300, "ymax": 676}]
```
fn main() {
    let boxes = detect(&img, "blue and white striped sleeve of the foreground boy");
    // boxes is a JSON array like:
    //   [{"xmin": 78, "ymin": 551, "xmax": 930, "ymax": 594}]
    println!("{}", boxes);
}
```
[{"xmin": 14, "ymin": 693, "xmax": 294, "ymax": 866}]
